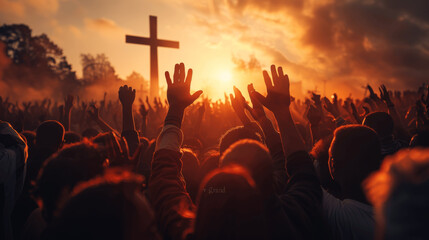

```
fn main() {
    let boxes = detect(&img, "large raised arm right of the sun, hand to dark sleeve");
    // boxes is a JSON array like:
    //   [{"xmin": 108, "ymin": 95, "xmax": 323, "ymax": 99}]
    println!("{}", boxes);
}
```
[{"xmin": 253, "ymin": 65, "xmax": 323, "ymax": 239}]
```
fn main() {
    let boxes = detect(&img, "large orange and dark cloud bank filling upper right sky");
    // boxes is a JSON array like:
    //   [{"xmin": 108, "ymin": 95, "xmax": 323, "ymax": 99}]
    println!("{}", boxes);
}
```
[{"xmin": 186, "ymin": 0, "xmax": 429, "ymax": 95}]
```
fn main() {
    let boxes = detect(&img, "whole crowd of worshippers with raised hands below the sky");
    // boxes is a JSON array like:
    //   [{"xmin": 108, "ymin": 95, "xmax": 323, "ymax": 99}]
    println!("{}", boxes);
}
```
[{"xmin": 0, "ymin": 63, "xmax": 429, "ymax": 240}]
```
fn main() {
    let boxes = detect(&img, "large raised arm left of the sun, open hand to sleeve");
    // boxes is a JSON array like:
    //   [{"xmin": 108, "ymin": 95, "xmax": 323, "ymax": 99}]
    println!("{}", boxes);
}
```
[{"xmin": 148, "ymin": 63, "xmax": 202, "ymax": 239}]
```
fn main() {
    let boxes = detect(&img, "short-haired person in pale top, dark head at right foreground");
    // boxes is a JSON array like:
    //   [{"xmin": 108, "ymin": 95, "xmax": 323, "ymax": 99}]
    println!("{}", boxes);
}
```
[{"xmin": 323, "ymin": 125, "xmax": 381, "ymax": 239}]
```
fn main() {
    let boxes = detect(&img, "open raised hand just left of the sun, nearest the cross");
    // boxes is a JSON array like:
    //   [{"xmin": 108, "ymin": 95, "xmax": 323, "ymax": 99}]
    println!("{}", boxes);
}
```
[{"xmin": 165, "ymin": 63, "xmax": 203, "ymax": 111}]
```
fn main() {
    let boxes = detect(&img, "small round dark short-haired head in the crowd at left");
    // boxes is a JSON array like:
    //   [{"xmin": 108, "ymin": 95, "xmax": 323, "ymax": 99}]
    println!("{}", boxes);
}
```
[{"xmin": 36, "ymin": 120, "xmax": 65, "ymax": 151}]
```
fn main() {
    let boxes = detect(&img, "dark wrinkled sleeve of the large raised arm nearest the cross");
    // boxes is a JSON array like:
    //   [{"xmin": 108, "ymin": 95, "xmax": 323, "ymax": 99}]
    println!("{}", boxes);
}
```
[{"xmin": 148, "ymin": 127, "xmax": 195, "ymax": 239}]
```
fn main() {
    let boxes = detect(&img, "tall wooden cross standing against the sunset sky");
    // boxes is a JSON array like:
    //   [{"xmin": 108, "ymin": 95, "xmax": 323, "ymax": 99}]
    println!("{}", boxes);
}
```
[{"xmin": 125, "ymin": 16, "xmax": 179, "ymax": 98}]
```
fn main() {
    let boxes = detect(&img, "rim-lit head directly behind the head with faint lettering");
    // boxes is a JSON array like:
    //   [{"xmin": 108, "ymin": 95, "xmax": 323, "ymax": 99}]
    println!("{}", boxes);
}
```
[{"xmin": 219, "ymin": 139, "xmax": 273, "ymax": 193}]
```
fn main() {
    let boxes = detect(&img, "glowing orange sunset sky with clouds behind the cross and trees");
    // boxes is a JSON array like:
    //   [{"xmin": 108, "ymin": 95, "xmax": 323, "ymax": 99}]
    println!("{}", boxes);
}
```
[{"xmin": 0, "ymin": 0, "xmax": 429, "ymax": 98}]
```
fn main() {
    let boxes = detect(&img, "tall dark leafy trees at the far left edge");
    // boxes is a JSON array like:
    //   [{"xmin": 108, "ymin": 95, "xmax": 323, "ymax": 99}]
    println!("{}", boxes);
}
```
[{"xmin": 0, "ymin": 24, "xmax": 81, "ymax": 96}]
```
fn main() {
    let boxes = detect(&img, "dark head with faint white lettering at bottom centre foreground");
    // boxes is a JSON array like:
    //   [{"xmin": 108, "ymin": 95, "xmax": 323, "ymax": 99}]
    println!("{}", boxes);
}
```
[{"xmin": 194, "ymin": 165, "xmax": 268, "ymax": 239}]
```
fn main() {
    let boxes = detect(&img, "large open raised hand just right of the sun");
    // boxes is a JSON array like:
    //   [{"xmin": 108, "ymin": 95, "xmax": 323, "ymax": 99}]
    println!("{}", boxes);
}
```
[{"xmin": 254, "ymin": 65, "xmax": 291, "ymax": 114}]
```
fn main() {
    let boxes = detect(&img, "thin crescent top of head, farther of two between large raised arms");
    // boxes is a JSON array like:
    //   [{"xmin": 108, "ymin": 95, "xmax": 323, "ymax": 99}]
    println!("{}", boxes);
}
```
[{"xmin": 219, "ymin": 126, "xmax": 262, "ymax": 156}]
